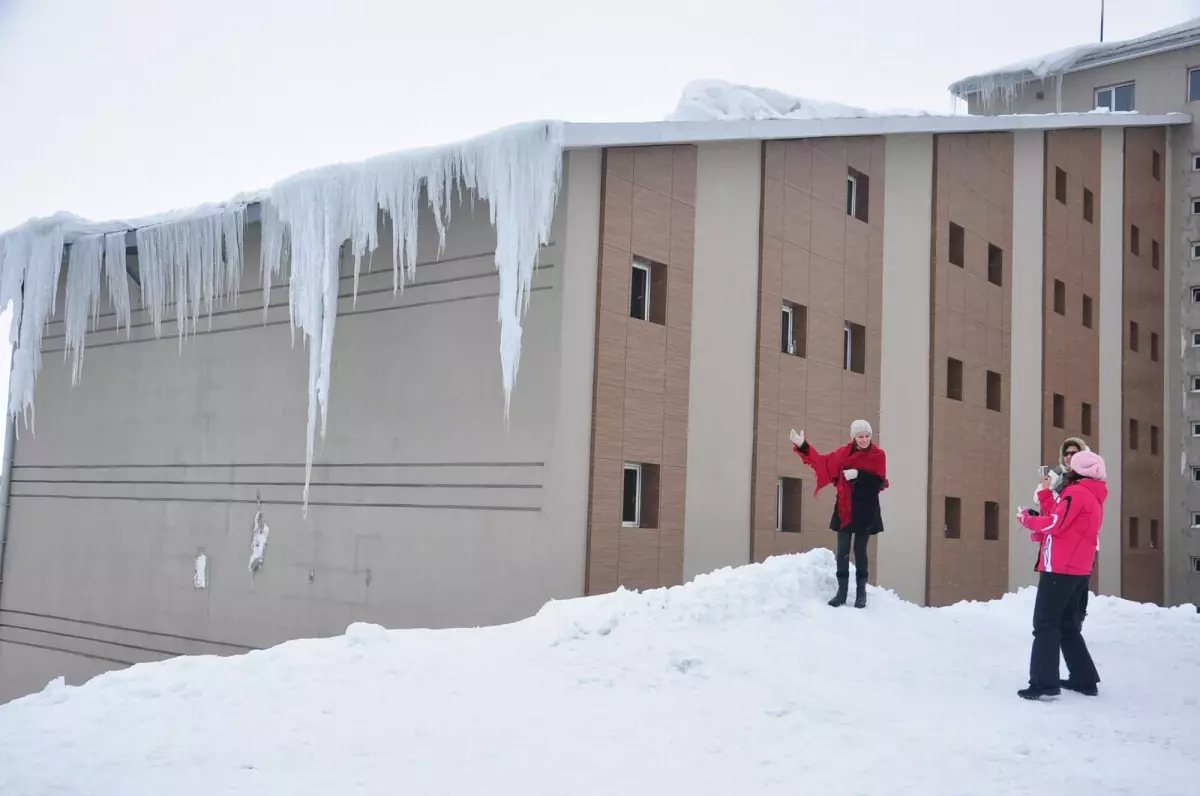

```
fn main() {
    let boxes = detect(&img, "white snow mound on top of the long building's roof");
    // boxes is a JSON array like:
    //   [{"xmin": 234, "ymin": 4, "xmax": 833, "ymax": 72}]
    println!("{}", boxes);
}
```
[{"xmin": 666, "ymin": 79, "xmax": 930, "ymax": 121}]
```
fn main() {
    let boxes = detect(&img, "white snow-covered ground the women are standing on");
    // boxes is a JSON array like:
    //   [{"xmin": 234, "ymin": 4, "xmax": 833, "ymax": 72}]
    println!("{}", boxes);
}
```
[{"xmin": 0, "ymin": 550, "xmax": 1200, "ymax": 796}]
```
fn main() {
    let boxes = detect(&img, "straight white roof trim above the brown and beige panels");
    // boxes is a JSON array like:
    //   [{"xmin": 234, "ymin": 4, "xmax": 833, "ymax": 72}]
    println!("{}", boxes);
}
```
[{"xmin": 564, "ymin": 113, "xmax": 1192, "ymax": 149}]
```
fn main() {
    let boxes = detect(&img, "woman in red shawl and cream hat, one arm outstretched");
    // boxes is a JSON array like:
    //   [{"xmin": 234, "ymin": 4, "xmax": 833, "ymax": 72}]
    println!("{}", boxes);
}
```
[{"xmin": 790, "ymin": 420, "xmax": 888, "ymax": 608}]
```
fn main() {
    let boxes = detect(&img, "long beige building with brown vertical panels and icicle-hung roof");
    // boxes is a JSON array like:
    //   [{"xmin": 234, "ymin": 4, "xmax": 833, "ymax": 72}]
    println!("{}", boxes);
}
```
[{"xmin": 0, "ymin": 104, "xmax": 1190, "ymax": 699}]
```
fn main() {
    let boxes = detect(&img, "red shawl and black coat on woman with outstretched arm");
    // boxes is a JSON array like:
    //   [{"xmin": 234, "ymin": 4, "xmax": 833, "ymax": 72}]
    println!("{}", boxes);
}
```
[{"xmin": 792, "ymin": 441, "xmax": 888, "ymax": 535}]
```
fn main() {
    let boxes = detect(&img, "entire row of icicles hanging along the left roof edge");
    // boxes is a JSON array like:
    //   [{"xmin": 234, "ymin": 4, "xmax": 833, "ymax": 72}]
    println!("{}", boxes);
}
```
[{"xmin": 0, "ymin": 122, "xmax": 563, "ymax": 501}]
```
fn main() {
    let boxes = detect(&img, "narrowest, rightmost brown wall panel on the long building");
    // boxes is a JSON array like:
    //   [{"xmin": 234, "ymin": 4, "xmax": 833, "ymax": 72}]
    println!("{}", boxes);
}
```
[{"xmin": 1106, "ymin": 127, "xmax": 1166, "ymax": 604}]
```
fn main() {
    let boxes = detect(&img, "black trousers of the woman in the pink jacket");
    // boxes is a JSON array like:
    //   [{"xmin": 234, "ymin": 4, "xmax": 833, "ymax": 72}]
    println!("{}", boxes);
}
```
[{"xmin": 1030, "ymin": 573, "xmax": 1100, "ymax": 688}]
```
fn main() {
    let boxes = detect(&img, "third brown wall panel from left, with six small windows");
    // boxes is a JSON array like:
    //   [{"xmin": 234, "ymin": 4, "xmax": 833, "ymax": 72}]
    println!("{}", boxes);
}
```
[{"xmin": 926, "ymin": 133, "xmax": 1012, "ymax": 605}]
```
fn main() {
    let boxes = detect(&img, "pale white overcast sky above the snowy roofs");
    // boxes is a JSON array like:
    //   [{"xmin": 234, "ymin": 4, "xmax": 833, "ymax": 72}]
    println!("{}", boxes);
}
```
[{"xmin": 0, "ymin": 0, "xmax": 1200, "ymax": 229}]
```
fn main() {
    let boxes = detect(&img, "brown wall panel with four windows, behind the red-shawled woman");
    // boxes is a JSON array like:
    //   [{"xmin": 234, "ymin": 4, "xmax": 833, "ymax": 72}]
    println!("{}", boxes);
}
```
[{"xmin": 751, "ymin": 138, "xmax": 886, "ymax": 569}]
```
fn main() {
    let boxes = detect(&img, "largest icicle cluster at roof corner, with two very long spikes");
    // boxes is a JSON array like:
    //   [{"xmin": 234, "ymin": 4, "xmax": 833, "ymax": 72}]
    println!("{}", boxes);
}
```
[{"xmin": 262, "ymin": 122, "xmax": 563, "ymax": 501}]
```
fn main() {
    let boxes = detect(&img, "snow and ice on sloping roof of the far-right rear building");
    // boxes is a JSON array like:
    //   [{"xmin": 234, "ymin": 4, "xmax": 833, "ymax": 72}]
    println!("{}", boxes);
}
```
[{"xmin": 949, "ymin": 17, "xmax": 1200, "ymax": 100}]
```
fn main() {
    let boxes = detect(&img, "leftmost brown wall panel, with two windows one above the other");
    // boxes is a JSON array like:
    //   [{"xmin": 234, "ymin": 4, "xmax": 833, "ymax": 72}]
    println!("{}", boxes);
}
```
[{"xmin": 587, "ymin": 146, "xmax": 696, "ymax": 594}]
